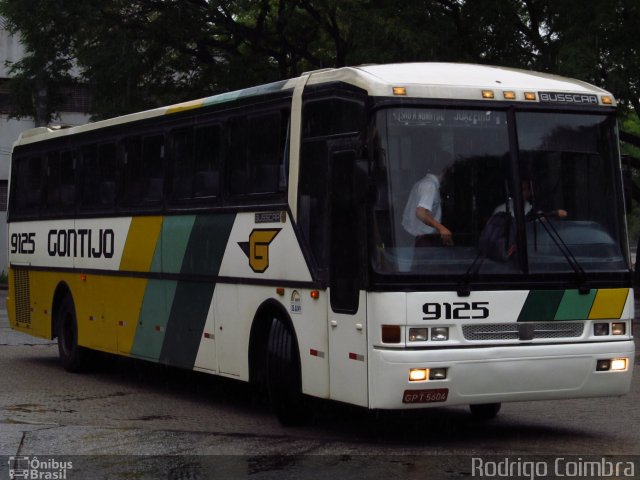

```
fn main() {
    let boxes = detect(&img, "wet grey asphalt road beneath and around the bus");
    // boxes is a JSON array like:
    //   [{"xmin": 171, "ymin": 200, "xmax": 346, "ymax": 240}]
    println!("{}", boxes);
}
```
[{"xmin": 0, "ymin": 294, "xmax": 640, "ymax": 480}]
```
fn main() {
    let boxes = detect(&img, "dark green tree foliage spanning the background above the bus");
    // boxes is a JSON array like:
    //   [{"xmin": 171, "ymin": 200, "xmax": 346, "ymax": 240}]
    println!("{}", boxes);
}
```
[{"xmin": 0, "ymin": 0, "xmax": 640, "ymax": 127}]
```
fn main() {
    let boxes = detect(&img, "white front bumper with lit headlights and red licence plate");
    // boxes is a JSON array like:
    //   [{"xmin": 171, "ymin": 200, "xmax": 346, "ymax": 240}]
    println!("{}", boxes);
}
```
[{"xmin": 369, "ymin": 340, "xmax": 635, "ymax": 409}]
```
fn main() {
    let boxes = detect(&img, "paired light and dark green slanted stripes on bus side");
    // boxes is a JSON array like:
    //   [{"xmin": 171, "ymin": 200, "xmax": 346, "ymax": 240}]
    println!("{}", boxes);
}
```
[{"xmin": 123, "ymin": 213, "xmax": 235, "ymax": 370}]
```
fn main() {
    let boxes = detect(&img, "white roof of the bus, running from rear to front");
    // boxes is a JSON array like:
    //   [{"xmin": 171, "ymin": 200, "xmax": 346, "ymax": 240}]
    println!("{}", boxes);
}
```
[{"xmin": 15, "ymin": 63, "xmax": 615, "ymax": 145}]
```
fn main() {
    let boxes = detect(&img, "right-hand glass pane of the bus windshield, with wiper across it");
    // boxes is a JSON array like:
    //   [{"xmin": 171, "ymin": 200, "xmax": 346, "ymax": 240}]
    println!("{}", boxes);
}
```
[{"xmin": 516, "ymin": 113, "xmax": 626, "ymax": 272}]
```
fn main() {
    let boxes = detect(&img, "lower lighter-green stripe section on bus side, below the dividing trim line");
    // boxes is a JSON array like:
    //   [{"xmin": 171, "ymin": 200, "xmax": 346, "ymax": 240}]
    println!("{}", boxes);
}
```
[{"xmin": 131, "ymin": 280, "xmax": 177, "ymax": 361}]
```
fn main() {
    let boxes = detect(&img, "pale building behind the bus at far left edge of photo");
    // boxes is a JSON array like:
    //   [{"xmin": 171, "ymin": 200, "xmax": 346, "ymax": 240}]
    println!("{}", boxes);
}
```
[{"xmin": 0, "ymin": 17, "xmax": 91, "ymax": 272}]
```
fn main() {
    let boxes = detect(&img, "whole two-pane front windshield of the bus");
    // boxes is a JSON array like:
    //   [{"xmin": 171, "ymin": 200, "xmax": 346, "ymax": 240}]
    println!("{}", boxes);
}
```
[{"xmin": 372, "ymin": 108, "xmax": 627, "ymax": 276}]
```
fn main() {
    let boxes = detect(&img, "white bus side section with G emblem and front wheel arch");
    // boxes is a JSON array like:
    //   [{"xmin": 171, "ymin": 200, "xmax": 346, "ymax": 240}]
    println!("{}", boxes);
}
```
[{"xmin": 218, "ymin": 211, "xmax": 329, "ymax": 398}]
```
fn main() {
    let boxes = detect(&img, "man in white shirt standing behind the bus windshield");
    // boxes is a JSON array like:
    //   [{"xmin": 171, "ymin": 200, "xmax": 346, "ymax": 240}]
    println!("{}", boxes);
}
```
[{"xmin": 402, "ymin": 156, "xmax": 453, "ymax": 247}]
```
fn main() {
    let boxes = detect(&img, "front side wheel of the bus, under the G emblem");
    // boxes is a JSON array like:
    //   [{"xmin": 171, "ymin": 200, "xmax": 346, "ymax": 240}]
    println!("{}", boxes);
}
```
[{"xmin": 266, "ymin": 318, "xmax": 305, "ymax": 425}]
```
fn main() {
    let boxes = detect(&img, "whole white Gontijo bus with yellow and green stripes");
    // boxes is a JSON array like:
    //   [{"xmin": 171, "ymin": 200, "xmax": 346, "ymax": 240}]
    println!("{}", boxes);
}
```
[{"xmin": 7, "ymin": 63, "xmax": 634, "ymax": 423}]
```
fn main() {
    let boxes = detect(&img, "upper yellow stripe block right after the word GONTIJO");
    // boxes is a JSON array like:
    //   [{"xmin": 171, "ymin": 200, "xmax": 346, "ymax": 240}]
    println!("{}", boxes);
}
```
[{"xmin": 120, "ymin": 217, "xmax": 162, "ymax": 272}]
